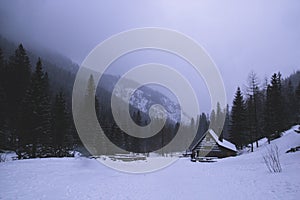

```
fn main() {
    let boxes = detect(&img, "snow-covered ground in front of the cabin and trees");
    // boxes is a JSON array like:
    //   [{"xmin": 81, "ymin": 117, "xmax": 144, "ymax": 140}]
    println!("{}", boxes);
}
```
[{"xmin": 0, "ymin": 127, "xmax": 300, "ymax": 200}]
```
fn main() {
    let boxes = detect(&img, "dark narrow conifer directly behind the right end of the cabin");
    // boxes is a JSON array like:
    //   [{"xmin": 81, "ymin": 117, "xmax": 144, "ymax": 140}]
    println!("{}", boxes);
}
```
[{"xmin": 230, "ymin": 87, "xmax": 246, "ymax": 149}]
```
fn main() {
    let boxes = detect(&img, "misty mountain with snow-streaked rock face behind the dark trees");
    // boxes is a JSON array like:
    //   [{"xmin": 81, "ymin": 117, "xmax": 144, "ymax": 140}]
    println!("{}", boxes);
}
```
[{"xmin": 0, "ymin": 36, "xmax": 186, "ymax": 123}]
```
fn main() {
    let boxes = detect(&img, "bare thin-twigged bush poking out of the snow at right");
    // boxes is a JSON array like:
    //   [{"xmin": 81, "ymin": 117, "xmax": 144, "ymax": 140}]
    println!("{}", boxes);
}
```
[{"xmin": 263, "ymin": 145, "xmax": 282, "ymax": 173}]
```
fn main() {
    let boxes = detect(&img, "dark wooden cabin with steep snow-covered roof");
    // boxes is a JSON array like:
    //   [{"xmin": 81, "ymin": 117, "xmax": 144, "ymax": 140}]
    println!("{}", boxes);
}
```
[{"xmin": 192, "ymin": 129, "xmax": 237, "ymax": 158}]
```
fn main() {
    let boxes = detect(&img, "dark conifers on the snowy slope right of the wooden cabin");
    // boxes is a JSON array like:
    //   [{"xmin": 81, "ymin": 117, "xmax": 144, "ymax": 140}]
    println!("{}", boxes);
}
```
[{"xmin": 228, "ymin": 72, "xmax": 300, "ymax": 151}]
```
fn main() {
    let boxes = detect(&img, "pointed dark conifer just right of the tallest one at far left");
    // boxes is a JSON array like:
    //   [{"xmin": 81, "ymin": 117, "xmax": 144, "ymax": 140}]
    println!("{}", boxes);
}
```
[{"xmin": 18, "ymin": 58, "xmax": 51, "ymax": 158}]
